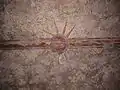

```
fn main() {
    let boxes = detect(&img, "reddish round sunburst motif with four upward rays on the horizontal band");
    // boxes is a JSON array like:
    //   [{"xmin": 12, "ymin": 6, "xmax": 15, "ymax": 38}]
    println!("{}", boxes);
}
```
[{"xmin": 43, "ymin": 20, "xmax": 75, "ymax": 54}]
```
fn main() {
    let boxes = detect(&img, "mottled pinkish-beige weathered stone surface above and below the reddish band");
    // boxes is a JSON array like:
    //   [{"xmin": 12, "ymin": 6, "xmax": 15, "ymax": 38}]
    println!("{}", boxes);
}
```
[{"xmin": 0, "ymin": 0, "xmax": 120, "ymax": 90}]
